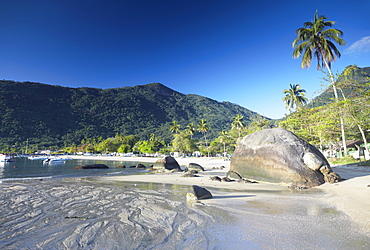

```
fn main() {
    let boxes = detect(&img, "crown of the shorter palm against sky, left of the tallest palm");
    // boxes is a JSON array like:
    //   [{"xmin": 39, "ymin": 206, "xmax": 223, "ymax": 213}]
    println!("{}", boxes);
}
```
[{"xmin": 283, "ymin": 84, "xmax": 308, "ymax": 111}]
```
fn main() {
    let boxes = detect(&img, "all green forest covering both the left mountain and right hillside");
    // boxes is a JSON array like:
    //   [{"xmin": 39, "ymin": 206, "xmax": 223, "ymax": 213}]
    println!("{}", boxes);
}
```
[{"xmin": 0, "ymin": 66, "xmax": 370, "ymax": 155}]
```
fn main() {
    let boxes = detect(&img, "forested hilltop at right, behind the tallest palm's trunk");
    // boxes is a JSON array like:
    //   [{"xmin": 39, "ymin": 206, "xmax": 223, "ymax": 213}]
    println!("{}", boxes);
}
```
[{"xmin": 308, "ymin": 65, "xmax": 370, "ymax": 108}]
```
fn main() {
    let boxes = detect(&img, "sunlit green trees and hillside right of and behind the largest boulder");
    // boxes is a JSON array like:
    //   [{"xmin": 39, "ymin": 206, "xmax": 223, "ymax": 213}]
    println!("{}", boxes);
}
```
[{"xmin": 279, "ymin": 65, "xmax": 370, "ymax": 153}]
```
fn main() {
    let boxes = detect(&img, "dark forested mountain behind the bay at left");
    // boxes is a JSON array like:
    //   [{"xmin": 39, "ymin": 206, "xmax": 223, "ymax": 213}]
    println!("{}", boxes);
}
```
[{"xmin": 0, "ymin": 80, "xmax": 261, "ymax": 149}]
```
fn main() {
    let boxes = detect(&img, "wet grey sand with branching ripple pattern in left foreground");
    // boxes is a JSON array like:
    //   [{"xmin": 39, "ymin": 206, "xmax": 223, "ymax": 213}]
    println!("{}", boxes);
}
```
[{"xmin": 0, "ymin": 180, "xmax": 237, "ymax": 249}]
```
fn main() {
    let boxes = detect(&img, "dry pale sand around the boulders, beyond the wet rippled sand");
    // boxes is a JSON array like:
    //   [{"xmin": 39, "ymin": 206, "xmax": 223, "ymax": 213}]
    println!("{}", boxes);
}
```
[{"xmin": 69, "ymin": 156, "xmax": 370, "ymax": 237}]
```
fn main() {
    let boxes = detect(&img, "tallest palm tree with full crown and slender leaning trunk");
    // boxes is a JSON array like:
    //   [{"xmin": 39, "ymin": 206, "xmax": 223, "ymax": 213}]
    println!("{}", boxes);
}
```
[{"xmin": 292, "ymin": 11, "xmax": 347, "ymax": 155}]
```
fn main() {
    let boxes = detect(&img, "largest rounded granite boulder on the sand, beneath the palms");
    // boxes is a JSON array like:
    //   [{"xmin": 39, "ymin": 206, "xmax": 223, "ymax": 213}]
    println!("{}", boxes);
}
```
[{"xmin": 230, "ymin": 128, "xmax": 340, "ymax": 187}]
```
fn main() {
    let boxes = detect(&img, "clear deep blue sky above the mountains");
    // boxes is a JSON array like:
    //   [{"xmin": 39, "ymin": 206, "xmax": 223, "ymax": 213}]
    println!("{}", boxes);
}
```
[{"xmin": 0, "ymin": 0, "xmax": 370, "ymax": 118}]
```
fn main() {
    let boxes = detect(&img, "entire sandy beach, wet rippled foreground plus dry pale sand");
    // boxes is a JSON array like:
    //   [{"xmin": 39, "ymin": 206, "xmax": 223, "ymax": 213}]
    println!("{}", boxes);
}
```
[{"xmin": 0, "ymin": 156, "xmax": 370, "ymax": 249}]
